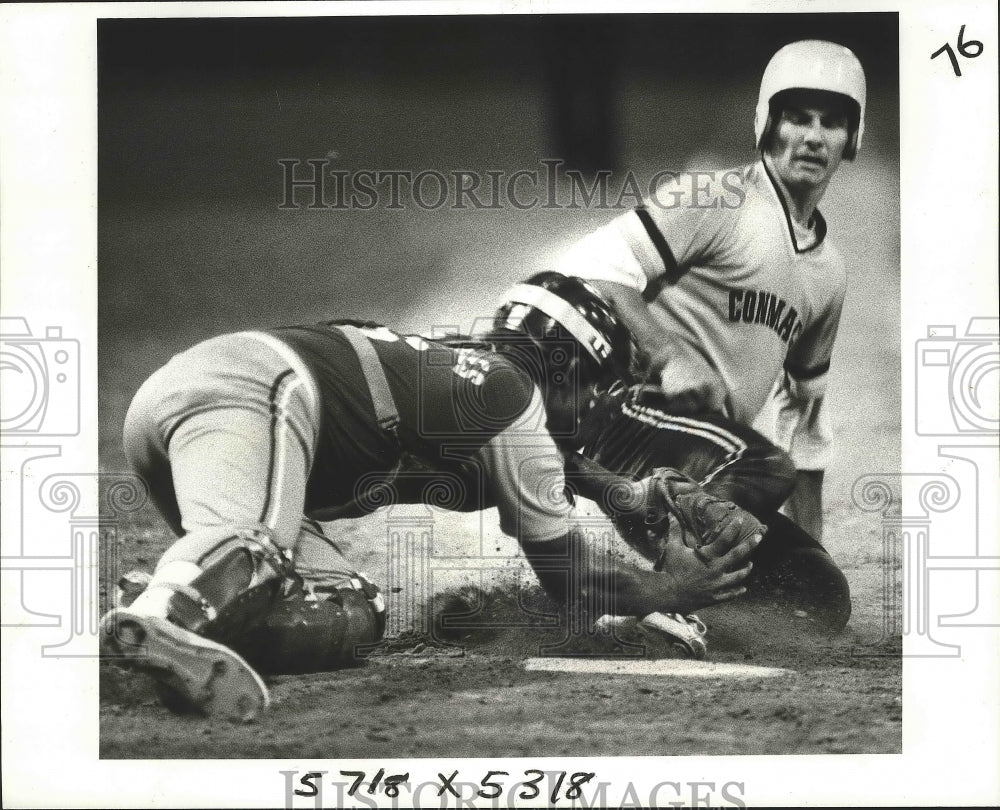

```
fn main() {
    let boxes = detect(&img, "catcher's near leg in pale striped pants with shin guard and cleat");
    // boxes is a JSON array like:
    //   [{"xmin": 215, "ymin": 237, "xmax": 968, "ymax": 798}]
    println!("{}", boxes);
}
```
[{"xmin": 102, "ymin": 335, "xmax": 319, "ymax": 718}]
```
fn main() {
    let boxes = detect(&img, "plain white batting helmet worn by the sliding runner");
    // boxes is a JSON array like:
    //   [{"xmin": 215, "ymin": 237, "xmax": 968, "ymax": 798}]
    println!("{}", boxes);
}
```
[{"xmin": 753, "ymin": 39, "xmax": 865, "ymax": 160}]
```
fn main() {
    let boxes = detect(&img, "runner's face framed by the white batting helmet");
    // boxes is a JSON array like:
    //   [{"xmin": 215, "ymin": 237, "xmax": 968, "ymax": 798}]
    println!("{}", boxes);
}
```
[{"xmin": 768, "ymin": 96, "xmax": 850, "ymax": 190}]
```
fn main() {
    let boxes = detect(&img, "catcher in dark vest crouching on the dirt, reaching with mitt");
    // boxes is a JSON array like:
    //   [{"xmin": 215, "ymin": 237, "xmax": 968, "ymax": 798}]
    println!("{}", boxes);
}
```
[{"xmin": 101, "ymin": 273, "xmax": 763, "ymax": 719}]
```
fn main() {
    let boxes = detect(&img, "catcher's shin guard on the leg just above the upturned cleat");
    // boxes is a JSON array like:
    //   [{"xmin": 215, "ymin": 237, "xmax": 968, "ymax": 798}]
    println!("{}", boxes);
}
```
[{"xmin": 166, "ymin": 526, "xmax": 297, "ymax": 644}]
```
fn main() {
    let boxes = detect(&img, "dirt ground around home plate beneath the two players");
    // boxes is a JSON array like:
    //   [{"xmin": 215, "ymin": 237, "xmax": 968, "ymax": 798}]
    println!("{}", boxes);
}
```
[{"xmin": 100, "ymin": 496, "xmax": 902, "ymax": 759}]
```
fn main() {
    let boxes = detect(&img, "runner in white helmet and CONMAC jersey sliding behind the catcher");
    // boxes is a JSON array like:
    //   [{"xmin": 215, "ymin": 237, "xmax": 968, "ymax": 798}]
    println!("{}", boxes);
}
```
[{"xmin": 564, "ymin": 40, "xmax": 865, "ymax": 539}]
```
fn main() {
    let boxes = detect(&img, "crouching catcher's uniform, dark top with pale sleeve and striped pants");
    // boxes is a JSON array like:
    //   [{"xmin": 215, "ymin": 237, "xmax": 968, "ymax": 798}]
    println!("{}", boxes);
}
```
[{"xmin": 124, "ymin": 324, "xmax": 570, "ymax": 565}]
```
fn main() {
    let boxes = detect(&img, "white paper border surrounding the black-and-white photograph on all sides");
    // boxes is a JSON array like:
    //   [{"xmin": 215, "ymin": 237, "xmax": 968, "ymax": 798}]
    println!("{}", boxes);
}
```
[{"xmin": 0, "ymin": 0, "xmax": 1000, "ymax": 807}]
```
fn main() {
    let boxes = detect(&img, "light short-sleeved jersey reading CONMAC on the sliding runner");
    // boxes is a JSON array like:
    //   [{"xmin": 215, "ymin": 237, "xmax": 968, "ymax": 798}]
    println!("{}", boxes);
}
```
[{"xmin": 560, "ymin": 162, "xmax": 846, "ymax": 468}]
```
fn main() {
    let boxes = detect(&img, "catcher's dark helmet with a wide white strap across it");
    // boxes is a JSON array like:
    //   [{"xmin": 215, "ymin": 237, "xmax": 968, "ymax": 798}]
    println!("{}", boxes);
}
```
[{"xmin": 490, "ymin": 272, "xmax": 633, "ymax": 388}]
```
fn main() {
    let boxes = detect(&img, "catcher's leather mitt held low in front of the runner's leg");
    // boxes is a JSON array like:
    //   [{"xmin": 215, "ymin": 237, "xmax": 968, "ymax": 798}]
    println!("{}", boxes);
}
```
[{"xmin": 615, "ymin": 467, "xmax": 767, "ymax": 571}]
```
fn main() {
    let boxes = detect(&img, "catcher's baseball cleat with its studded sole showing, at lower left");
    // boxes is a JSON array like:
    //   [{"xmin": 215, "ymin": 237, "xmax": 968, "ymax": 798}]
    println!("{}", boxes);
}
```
[{"xmin": 100, "ymin": 608, "xmax": 271, "ymax": 721}]
